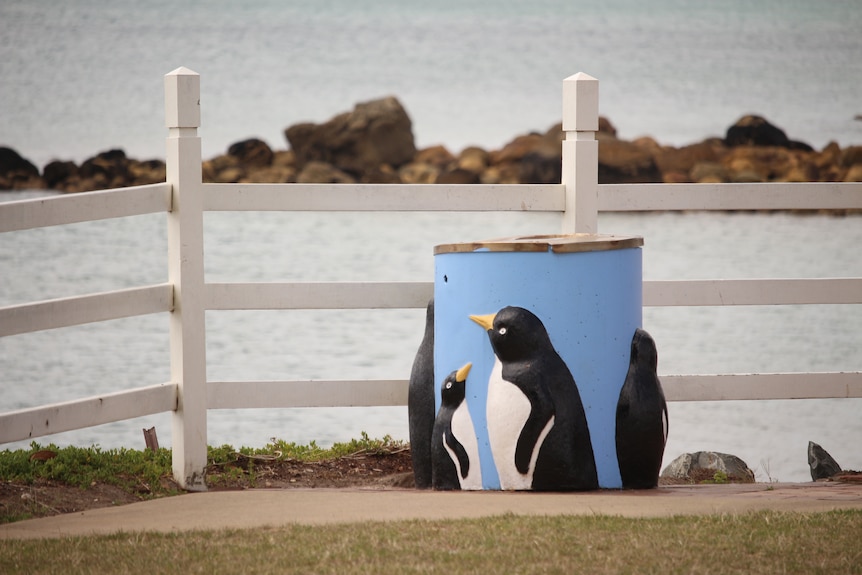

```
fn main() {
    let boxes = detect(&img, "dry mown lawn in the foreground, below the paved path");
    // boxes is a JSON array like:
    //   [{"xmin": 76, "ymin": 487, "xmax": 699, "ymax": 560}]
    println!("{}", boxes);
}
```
[{"xmin": 0, "ymin": 511, "xmax": 862, "ymax": 575}]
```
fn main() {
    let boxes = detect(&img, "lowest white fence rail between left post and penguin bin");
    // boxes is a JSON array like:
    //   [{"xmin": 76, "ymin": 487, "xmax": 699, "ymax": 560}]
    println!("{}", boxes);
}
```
[{"xmin": 207, "ymin": 379, "xmax": 407, "ymax": 409}]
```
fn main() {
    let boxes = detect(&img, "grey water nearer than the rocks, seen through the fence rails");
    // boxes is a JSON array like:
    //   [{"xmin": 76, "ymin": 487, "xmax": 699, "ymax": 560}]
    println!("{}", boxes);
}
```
[{"xmin": 0, "ymin": 188, "xmax": 862, "ymax": 481}]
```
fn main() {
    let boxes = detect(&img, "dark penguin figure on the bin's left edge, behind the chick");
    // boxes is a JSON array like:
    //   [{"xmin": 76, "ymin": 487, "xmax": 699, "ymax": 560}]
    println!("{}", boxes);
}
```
[{"xmin": 407, "ymin": 299, "xmax": 434, "ymax": 489}]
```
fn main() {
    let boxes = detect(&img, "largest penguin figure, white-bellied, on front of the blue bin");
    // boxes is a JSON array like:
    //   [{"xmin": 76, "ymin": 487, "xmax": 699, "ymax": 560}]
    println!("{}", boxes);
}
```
[{"xmin": 470, "ymin": 307, "xmax": 598, "ymax": 491}]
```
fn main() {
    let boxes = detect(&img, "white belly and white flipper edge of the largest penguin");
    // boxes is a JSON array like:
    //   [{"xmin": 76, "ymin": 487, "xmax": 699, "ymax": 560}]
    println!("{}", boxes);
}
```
[{"xmin": 487, "ymin": 359, "xmax": 554, "ymax": 490}]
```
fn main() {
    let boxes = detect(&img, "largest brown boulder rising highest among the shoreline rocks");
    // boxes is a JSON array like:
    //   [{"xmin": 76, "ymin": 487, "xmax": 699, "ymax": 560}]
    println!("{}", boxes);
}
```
[{"xmin": 284, "ymin": 96, "xmax": 416, "ymax": 180}]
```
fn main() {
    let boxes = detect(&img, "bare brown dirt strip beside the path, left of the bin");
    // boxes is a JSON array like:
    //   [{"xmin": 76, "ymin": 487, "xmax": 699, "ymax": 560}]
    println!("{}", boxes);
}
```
[{"xmin": 0, "ymin": 448, "xmax": 414, "ymax": 522}]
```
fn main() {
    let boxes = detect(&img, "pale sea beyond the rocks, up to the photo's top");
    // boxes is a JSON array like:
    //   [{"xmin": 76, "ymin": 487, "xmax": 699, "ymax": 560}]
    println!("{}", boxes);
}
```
[{"xmin": 0, "ymin": 0, "xmax": 862, "ymax": 171}]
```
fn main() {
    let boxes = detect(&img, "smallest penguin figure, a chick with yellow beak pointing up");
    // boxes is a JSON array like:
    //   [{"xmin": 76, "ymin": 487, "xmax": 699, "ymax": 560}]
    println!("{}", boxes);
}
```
[{"xmin": 431, "ymin": 363, "xmax": 482, "ymax": 490}]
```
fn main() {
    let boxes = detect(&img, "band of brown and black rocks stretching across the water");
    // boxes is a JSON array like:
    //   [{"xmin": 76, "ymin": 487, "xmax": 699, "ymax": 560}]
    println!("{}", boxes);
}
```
[{"xmin": 0, "ymin": 97, "xmax": 862, "ymax": 214}]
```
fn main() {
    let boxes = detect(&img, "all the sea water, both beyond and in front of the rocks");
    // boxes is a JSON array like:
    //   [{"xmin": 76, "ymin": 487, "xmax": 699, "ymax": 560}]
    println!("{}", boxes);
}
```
[{"xmin": 0, "ymin": 0, "xmax": 862, "ymax": 481}]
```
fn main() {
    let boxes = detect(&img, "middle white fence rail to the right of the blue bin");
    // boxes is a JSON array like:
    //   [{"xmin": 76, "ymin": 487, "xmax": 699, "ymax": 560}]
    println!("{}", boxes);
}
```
[{"xmin": 643, "ymin": 278, "xmax": 862, "ymax": 306}]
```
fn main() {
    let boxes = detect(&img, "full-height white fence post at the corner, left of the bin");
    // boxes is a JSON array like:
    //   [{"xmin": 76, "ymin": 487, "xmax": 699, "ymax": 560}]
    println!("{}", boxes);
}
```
[{"xmin": 165, "ymin": 67, "xmax": 207, "ymax": 491}]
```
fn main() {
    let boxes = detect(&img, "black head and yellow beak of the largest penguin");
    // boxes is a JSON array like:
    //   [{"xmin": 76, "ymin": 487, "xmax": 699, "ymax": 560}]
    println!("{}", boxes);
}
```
[{"xmin": 470, "ymin": 306, "xmax": 551, "ymax": 361}]
